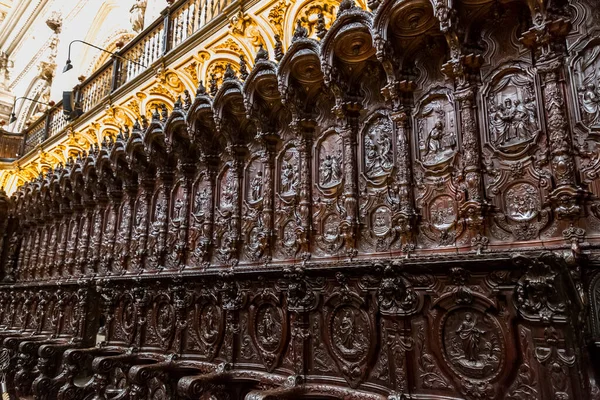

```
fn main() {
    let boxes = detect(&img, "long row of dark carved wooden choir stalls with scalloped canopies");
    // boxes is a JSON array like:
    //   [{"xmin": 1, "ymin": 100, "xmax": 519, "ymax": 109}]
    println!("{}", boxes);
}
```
[{"xmin": 0, "ymin": 0, "xmax": 600, "ymax": 400}]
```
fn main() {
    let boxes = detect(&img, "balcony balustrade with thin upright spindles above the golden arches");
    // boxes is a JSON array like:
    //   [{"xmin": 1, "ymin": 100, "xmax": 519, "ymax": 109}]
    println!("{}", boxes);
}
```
[{"xmin": 19, "ymin": 0, "xmax": 234, "ymax": 156}]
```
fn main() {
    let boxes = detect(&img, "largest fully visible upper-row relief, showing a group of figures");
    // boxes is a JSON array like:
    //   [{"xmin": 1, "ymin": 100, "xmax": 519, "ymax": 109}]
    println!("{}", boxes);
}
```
[{"xmin": 487, "ymin": 73, "xmax": 539, "ymax": 153}]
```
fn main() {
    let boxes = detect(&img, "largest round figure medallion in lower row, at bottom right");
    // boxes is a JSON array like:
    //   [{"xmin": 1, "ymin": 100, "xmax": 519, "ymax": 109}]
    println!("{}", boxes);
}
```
[{"xmin": 443, "ymin": 310, "xmax": 504, "ymax": 379}]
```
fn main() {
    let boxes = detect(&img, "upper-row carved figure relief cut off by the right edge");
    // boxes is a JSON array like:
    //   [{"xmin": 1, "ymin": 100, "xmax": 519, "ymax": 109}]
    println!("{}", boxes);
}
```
[{"xmin": 574, "ymin": 45, "xmax": 600, "ymax": 128}]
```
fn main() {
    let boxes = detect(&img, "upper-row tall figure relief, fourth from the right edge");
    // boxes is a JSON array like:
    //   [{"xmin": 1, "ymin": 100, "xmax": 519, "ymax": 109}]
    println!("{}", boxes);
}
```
[{"xmin": 364, "ymin": 118, "xmax": 394, "ymax": 178}]
